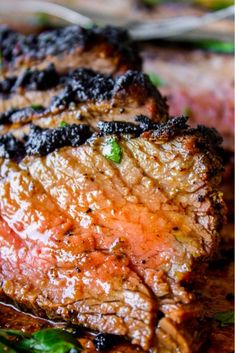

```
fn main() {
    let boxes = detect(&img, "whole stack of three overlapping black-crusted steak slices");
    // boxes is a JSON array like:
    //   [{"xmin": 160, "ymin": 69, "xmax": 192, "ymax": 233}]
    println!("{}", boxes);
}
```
[{"xmin": 0, "ymin": 27, "xmax": 225, "ymax": 353}]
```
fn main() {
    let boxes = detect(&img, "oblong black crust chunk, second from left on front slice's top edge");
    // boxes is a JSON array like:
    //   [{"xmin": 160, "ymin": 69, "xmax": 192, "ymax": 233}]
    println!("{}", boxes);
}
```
[{"xmin": 25, "ymin": 124, "xmax": 91, "ymax": 156}]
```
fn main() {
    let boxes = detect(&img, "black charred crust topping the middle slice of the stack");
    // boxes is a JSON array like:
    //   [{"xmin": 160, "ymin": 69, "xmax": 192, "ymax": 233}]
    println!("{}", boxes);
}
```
[{"xmin": 0, "ymin": 65, "xmax": 162, "ymax": 125}]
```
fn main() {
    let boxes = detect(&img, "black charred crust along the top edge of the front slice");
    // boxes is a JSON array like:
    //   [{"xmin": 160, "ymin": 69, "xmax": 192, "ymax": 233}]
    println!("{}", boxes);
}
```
[{"xmin": 0, "ymin": 115, "xmax": 222, "ymax": 166}]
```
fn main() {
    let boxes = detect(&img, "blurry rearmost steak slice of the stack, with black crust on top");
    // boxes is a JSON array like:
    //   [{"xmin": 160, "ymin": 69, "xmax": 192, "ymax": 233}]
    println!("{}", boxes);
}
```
[{"xmin": 0, "ymin": 26, "xmax": 141, "ymax": 77}]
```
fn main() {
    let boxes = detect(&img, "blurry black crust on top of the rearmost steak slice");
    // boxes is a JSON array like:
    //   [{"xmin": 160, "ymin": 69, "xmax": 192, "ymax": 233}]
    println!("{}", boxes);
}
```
[{"xmin": 0, "ymin": 26, "xmax": 141, "ymax": 69}]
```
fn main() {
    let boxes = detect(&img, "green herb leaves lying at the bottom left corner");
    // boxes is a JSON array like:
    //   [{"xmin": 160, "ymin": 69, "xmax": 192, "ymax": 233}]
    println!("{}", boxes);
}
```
[{"xmin": 0, "ymin": 328, "xmax": 82, "ymax": 353}]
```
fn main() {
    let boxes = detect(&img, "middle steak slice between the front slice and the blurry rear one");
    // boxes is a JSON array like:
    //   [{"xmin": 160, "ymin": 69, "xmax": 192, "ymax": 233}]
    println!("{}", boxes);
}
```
[{"xmin": 0, "ymin": 69, "xmax": 168, "ymax": 137}]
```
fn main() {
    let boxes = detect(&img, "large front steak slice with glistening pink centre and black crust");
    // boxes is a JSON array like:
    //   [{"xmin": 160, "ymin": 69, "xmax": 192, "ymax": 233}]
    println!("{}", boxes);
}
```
[{"xmin": 0, "ymin": 117, "xmax": 224, "ymax": 353}]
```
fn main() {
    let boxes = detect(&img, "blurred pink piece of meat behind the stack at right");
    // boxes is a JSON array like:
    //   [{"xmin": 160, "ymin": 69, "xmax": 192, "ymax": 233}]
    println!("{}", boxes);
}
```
[{"xmin": 142, "ymin": 45, "xmax": 234, "ymax": 151}]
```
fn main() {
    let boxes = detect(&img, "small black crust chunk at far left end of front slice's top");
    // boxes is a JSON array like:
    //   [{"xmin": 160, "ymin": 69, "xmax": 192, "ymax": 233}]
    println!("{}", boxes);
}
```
[{"xmin": 0, "ymin": 134, "xmax": 25, "ymax": 162}]
